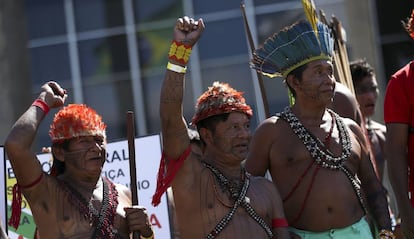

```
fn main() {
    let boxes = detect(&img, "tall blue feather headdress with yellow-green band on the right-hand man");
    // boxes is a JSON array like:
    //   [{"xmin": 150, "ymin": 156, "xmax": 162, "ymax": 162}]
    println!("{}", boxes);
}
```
[{"xmin": 250, "ymin": 20, "xmax": 334, "ymax": 78}]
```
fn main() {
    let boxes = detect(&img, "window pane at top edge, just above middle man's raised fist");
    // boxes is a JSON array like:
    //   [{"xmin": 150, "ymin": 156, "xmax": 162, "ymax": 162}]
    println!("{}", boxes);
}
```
[{"xmin": 134, "ymin": 0, "xmax": 183, "ymax": 23}]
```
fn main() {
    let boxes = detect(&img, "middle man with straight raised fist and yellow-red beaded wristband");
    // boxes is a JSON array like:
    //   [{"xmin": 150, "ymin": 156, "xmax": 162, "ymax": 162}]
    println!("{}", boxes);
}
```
[{"xmin": 153, "ymin": 17, "xmax": 289, "ymax": 239}]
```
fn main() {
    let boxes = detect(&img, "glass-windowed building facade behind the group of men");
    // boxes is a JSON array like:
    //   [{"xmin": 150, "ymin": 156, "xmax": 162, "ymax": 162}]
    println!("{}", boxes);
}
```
[{"xmin": 0, "ymin": 0, "xmax": 414, "ymax": 151}]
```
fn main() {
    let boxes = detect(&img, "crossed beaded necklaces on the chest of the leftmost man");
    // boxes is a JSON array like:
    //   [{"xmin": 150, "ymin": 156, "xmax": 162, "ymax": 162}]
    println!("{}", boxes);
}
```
[{"xmin": 58, "ymin": 178, "xmax": 120, "ymax": 239}]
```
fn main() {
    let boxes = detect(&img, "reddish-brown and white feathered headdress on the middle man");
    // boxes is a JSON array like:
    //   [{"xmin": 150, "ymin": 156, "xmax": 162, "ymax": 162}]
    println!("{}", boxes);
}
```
[{"xmin": 192, "ymin": 81, "xmax": 253, "ymax": 125}]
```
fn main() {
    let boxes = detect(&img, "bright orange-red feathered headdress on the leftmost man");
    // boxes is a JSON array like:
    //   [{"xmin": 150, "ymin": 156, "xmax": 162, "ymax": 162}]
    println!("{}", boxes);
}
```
[{"xmin": 49, "ymin": 104, "xmax": 106, "ymax": 143}]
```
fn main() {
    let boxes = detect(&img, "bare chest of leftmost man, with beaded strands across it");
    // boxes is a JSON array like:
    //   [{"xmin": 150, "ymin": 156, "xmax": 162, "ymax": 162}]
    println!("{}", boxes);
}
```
[{"xmin": 33, "ymin": 178, "xmax": 129, "ymax": 238}]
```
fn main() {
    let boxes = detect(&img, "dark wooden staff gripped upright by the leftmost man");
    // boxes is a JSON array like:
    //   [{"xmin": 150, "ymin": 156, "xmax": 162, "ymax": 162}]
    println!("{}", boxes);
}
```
[{"xmin": 126, "ymin": 111, "xmax": 140, "ymax": 239}]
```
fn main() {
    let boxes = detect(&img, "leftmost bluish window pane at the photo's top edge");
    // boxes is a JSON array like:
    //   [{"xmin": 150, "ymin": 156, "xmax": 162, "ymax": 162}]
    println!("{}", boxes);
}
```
[{"xmin": 25, "ymin": 0, "xmax": 66, "ymax": 39}]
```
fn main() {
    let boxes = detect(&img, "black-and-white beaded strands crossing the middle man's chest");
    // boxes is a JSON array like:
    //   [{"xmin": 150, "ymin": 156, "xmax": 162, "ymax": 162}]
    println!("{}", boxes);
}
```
[{"xmin": 201, "ymin": 161, "xmax": 273, "ymax": 239}]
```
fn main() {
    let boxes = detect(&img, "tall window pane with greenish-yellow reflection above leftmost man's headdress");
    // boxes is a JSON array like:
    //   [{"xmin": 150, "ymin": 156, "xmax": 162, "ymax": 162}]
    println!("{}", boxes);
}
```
[{"xmin": 79, "ymin": 35, "xmax": 133, "ymax": 141}]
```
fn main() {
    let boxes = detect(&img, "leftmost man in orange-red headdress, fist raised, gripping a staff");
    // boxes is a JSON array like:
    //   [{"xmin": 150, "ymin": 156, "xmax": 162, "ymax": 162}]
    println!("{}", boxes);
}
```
[{"xmin": 6, "ymin": 82, "xmax": 153, "ymax": 239}]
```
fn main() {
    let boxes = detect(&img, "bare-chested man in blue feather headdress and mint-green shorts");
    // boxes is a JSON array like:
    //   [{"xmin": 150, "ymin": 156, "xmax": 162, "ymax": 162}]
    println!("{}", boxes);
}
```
[{"xmin": 246, "ymin": 21, "xmax": 392, "ymax": 239}]
